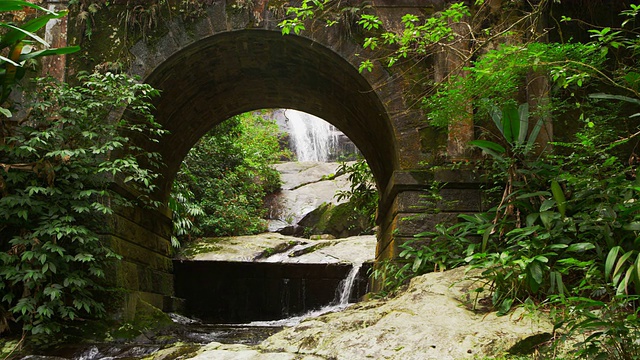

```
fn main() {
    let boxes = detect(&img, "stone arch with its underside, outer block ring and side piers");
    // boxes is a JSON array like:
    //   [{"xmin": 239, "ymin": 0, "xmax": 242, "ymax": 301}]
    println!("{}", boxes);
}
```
[{"xmin": 102, "ymin": 2, "xmax": 479, "ymax": 309}]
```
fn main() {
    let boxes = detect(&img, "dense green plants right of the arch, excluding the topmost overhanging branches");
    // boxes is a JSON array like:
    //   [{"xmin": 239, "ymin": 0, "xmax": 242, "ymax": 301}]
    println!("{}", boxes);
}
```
[{"xmin": 358, "ymin": 2, "xmax": 640, "ymax": 359}]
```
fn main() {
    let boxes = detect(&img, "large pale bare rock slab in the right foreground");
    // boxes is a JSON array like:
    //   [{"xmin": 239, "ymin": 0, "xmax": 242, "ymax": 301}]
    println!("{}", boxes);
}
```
[{"xmin": 260, "ymin": 269, "xmax": 552, "ymax": 360}]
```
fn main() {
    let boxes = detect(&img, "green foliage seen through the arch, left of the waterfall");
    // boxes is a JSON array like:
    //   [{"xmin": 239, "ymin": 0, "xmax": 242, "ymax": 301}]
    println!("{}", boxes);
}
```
[{"xmin": 174, "ymin": 109, "xmax": 286, "ymax": 236}]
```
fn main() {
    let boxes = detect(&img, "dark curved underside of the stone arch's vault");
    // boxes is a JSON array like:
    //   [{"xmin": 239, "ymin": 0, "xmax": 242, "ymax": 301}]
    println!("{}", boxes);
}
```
[{"xmin": 140, "ymin": 30, "xmax": 398, "ymax": 205}]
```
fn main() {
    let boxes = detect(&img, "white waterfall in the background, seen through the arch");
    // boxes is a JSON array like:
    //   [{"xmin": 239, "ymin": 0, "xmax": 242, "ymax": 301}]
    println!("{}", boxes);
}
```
[{"xmin": 285, "ymin": 109, "xmax": 339, "ymax": 162}]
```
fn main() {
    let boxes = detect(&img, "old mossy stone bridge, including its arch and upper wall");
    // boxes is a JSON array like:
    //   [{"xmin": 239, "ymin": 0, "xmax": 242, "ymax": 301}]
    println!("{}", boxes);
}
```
[{"xmin": 47, "ymin": 0, "xmax": 481, "ymax": 310}]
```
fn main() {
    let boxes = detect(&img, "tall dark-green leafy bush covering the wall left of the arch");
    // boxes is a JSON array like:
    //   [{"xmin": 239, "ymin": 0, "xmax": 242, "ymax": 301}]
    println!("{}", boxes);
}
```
[{"xmin": 0, "ymin": 73, "xmax": 162, "ymax": 335}]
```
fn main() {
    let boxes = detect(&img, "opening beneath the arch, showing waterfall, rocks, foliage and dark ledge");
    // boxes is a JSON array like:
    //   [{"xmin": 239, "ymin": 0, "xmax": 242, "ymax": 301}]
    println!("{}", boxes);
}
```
[{"xmin": 174, "ymin": 109, "xmax": 376, "ymax": 329}]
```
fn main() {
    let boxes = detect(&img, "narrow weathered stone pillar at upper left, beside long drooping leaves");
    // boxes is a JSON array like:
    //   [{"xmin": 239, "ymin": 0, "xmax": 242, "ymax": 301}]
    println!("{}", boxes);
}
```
[{"xmin": 40, "ymin": 0, "xmax": 68, "ymax": 81}]
